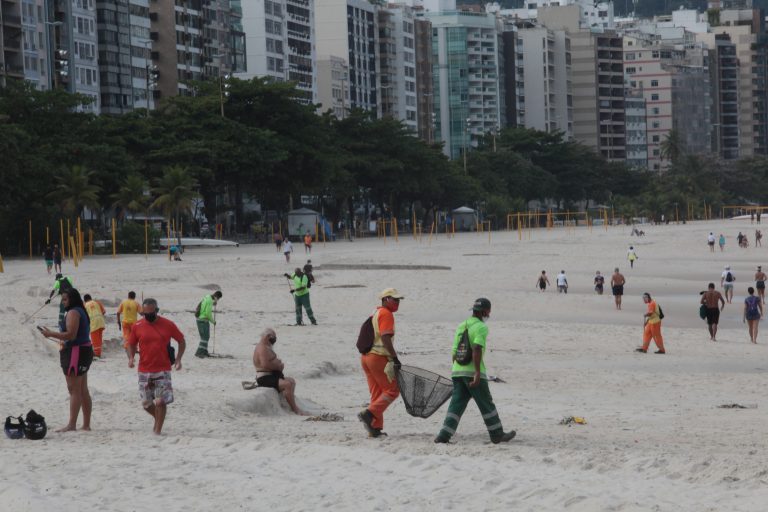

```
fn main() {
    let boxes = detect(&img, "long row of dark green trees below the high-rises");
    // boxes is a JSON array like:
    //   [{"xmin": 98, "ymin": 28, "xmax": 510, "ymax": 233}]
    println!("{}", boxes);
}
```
[{"xmin": 0, "ymin": 79, "xmax": 768, "ymax": 254}]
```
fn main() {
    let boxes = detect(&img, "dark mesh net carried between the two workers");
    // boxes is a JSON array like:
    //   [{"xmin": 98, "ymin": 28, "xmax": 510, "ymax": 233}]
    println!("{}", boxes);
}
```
[{"xmin": 397, "ymin": 365, "xmax": 453, "ymax": 418}]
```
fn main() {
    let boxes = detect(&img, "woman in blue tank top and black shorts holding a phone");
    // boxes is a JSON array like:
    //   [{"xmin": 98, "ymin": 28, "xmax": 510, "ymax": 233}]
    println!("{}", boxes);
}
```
[{"xmin": 40, "ymin": 288, "xmax": 93, "ymax": 432}]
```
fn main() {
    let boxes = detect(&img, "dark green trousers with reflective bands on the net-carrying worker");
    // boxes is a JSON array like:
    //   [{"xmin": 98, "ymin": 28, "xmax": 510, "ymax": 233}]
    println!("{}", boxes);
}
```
[{"xmin": 438, "ymin": 377, "xmax": 504, "ymax": 441}]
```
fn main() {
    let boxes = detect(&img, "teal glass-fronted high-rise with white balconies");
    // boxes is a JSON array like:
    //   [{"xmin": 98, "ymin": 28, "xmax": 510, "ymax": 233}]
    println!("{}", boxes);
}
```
[{"xmin": 424, "ymin": 11, "xmax": 506, "ymax": 158}]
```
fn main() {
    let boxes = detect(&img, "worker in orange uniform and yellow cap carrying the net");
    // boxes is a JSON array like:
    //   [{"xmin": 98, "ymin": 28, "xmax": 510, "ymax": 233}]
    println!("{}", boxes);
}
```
[{"xmin": 357, "ymin": 288, "xmax": 404, "ymax": 437}]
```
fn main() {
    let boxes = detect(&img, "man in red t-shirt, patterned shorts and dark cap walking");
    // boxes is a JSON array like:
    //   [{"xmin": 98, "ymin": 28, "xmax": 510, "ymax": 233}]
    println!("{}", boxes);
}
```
[{"xmin": 128, "ymin": 299, "xmax": 187, "ymax": 435}]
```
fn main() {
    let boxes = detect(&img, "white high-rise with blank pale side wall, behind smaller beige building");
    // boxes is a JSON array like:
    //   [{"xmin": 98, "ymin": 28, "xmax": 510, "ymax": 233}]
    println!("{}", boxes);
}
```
[{"xmin": 315, "ymin": 0, "xmax": 379, "ymax": 112}]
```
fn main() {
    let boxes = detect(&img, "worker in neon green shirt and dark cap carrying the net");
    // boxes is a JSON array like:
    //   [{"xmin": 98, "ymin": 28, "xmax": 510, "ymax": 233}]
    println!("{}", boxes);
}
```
[{"xmin": 435, "ymin": 298, "xmax": 516, "ymax": 444}]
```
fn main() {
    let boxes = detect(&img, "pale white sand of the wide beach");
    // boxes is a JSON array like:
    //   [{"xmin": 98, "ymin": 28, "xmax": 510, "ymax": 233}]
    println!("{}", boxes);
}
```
[{"xmin": 0, "ymin": 220, "xmax": 768, "ymax": 511}]
